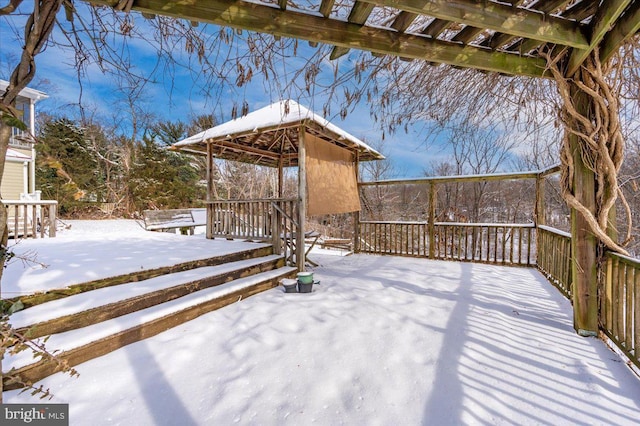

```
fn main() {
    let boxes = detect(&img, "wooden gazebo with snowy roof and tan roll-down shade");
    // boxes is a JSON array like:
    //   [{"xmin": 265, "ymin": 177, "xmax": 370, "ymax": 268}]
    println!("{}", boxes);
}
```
[{"xmin": 172, "ymin": 100, "xmax": 384, "ymax": 270}]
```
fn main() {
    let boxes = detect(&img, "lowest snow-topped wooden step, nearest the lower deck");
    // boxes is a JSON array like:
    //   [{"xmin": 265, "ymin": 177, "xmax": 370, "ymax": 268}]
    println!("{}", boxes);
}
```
[{"xmin": 2, "ymin": 267, "xmax": 296, "ymax": 390}]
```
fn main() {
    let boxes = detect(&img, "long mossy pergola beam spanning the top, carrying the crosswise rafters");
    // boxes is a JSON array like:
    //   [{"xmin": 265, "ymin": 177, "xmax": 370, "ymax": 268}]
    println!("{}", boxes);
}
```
[{"xmin": 89, "ymin": 0, "xmax": 548, "ymax": 77}]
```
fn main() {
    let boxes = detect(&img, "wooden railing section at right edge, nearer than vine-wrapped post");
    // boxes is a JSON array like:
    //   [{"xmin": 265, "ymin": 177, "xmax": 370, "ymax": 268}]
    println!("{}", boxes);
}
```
[{"xmin": 600, "ymin": 252, "xmax": 640, "ymax": 368}]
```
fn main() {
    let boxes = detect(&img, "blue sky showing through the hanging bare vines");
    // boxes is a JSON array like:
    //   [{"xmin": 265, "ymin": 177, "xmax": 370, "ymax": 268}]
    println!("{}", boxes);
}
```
[{"xmin": 0, "ymin": 2, "xmax": 524, "ymax": 178}]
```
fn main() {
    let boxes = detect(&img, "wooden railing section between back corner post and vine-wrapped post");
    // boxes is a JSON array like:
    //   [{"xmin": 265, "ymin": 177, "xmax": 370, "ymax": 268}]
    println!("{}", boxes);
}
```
[{"xmin": 537, "ymin": 226, "xmax": 571, "ymax": 299}]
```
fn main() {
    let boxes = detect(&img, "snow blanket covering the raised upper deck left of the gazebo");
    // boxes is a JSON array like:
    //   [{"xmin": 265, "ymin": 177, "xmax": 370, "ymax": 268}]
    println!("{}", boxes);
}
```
[{"xmin": 2, "ymin": 220, "xmax": 268, "ymax": 298}]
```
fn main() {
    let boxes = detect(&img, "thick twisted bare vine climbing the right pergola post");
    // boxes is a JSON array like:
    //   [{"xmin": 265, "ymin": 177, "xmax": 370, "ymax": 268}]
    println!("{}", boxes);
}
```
[{"xmin": 546, "ymin": 50, "xmax": 631, "ymax": 254}]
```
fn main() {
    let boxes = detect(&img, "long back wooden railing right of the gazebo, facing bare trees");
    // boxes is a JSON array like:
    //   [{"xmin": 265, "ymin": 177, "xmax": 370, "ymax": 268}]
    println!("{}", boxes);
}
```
[{"xmin": 359, "ymin": 221, "xmax": 535, "ymax": 266}]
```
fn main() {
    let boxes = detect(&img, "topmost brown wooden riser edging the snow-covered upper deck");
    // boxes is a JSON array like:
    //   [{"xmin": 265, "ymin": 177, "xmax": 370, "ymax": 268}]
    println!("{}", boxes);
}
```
[{"xmin": 7, "ymin": 244, "xmax": 273, "ymax": 309}]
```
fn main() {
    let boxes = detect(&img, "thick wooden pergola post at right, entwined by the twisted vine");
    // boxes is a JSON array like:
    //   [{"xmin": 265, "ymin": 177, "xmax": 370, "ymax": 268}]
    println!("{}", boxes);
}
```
[{"xmin": 569, "ymin": 84, "xmax": 598, "ymax": 336}]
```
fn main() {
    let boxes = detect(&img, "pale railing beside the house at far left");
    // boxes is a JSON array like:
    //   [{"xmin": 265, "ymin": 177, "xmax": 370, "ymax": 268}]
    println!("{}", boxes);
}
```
[{"xmin": 2, "ymin": 200, "xmax": 58, "ymax": 238}]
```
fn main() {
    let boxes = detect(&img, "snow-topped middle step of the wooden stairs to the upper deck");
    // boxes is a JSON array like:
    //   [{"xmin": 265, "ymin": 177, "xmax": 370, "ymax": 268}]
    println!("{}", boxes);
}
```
[{"xmin": 10, "ymin": 255, "xmax": 284, "ymax": 338}]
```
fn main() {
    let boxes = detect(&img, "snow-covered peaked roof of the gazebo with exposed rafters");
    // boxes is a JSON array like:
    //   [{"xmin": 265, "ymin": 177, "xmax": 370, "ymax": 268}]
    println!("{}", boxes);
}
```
[{"xmin": 172, "ymin": 100, "xmax": 384, "ymax": 167}]
